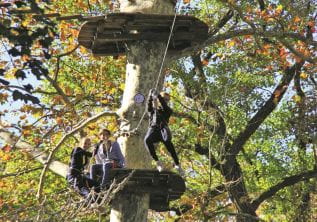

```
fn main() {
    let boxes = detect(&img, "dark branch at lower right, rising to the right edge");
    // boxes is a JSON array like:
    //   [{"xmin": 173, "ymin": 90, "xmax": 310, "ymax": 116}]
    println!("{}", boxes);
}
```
[{"xmin": 251, "ymin": 169, "xmax": 317, "ymax": 209}]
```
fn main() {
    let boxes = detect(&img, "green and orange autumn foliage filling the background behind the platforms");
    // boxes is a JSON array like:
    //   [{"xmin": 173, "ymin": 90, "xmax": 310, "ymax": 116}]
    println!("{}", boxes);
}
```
[{"xmin": 0, "ymin": 0, "xmax": 317, "ymax": 222}]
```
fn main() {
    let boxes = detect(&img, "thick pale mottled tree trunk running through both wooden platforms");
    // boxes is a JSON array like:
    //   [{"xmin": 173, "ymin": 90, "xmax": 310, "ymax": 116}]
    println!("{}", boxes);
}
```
[{"xmin": 110, "ymin": 0, "xmax": 173, "ymax": 222}]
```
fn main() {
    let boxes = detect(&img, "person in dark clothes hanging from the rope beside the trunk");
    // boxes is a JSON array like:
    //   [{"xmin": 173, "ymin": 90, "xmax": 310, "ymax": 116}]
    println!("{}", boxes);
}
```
[{"xmin": 144, "ymin": 89, "xmax": 184, "ymax": 175}]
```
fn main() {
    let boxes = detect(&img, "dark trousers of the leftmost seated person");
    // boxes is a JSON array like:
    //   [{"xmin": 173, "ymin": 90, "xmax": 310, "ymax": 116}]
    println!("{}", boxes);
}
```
[{"xmin": 66, "ymin": 173, "xmax": 97, "ymax": 197}]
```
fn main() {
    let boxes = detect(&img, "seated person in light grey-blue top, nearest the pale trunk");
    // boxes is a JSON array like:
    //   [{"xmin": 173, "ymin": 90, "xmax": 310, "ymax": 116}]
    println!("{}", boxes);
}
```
[{"xmin": 90, "ymin": 129, "xmax": 125, "ymax": 188}]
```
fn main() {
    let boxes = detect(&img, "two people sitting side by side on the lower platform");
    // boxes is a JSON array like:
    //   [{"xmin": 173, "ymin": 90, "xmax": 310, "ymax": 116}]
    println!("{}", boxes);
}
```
[{"xmin": 66, "ymin": 129, "xmax": 125, "ymax": 197}]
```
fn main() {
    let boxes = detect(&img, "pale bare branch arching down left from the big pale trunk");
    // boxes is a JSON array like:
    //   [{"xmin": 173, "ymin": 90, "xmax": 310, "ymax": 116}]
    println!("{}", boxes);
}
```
[{"xmin": 36, "ymin": 111, "xmax": 117, "ymax": 199}]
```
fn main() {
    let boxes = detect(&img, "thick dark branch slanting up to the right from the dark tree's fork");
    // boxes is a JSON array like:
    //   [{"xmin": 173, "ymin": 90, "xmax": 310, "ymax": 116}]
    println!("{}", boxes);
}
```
[{"xmin": 230, "ymin": 63, "xmax": 303, "ymax": 155}]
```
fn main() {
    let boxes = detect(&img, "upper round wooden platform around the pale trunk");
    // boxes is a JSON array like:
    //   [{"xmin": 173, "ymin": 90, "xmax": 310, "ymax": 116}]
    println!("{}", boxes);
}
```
[{"xmin": 78, "ymin": 13, "xmax": 208, "ymax": 56}]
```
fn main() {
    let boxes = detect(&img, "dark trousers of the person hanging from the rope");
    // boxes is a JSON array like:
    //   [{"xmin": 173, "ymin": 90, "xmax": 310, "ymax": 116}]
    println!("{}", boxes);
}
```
[{"xmin": 144, "ymin": 127, "xmax": 179, "ymax": 165}]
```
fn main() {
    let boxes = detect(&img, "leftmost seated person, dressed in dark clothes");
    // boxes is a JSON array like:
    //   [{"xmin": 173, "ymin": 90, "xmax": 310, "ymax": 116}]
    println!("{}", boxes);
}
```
[{"xmin": 66, "ymin": 137, "xmax": 97, "ymax": 198}]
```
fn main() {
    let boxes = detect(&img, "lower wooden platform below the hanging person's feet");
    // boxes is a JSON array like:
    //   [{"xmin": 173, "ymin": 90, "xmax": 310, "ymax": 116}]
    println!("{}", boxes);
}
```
[{"xmin": 104, "ymin": 169, "xmax": 186, "ymax": 211}]
